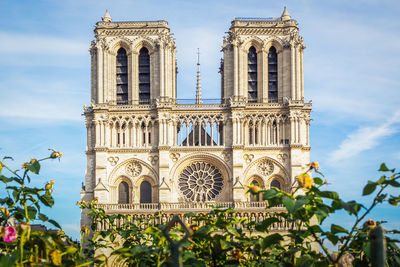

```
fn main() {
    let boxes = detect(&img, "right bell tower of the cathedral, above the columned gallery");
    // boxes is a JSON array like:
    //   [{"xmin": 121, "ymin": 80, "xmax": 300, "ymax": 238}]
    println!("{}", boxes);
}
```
[{"xmin": 222, "ymin": 7, "xmax": 305, "ymax": 103}]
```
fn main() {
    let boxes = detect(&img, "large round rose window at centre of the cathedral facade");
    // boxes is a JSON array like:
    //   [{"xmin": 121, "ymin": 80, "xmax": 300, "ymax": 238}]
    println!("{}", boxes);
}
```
[{"xmin": 178, "ymin": 162, "xmax": 224, "ymax": 201}]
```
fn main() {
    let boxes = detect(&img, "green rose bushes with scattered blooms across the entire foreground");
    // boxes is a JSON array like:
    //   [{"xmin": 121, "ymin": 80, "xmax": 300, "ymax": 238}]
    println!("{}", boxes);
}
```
[{"xmin": 0, "ymin": 150, "xmax": 400, "ymax": 266}]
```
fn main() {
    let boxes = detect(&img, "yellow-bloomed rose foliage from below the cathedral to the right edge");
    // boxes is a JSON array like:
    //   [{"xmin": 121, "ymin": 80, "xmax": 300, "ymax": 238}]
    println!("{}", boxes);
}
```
[{"xmin": 79, "ymin": 163, "xmax": 400, "ymax": 266}]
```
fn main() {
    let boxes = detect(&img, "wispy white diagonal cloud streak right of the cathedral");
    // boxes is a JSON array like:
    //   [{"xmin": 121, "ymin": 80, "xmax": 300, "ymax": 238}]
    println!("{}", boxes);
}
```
[{"xmin": 330, "ymin": 110, "xmax": 400, "ymax": 162}]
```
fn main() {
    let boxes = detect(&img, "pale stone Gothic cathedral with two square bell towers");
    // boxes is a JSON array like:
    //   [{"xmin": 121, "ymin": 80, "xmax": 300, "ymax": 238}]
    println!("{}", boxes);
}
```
[{"xmin": 81, "ymin": 8, "xmax": 311, "ymax": 228}]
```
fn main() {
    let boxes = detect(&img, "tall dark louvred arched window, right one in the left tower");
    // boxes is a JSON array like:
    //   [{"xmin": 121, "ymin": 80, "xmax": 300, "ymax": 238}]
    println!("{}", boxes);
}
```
[{"xmin": 139, "ymin": 47, "xmax": 150, "ymax": 104}]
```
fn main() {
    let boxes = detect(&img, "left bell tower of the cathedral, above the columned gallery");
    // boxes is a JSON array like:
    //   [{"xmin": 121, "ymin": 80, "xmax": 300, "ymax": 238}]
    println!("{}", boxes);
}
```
[{"xmin": 90, "ymin": 11, "xmax": 176, "ymax": 105}]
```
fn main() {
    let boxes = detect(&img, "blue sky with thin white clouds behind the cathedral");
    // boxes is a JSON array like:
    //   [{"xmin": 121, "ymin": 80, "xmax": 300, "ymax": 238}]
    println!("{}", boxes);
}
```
[{"xmin": 0, "ymin": 0, "xmax": 400, "ymax": 242}]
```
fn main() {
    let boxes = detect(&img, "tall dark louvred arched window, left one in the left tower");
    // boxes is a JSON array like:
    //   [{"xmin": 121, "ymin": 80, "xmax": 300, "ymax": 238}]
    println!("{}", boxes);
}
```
[{"xmin": 116, "ymin": 47, "xmax": 128, "ymax": 105}]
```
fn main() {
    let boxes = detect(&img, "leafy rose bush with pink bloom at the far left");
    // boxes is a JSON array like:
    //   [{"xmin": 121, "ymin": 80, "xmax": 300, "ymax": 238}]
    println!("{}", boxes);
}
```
[{"xmin": 0, "ymin": 150, "xmax": 91, "ymax": 266}]
